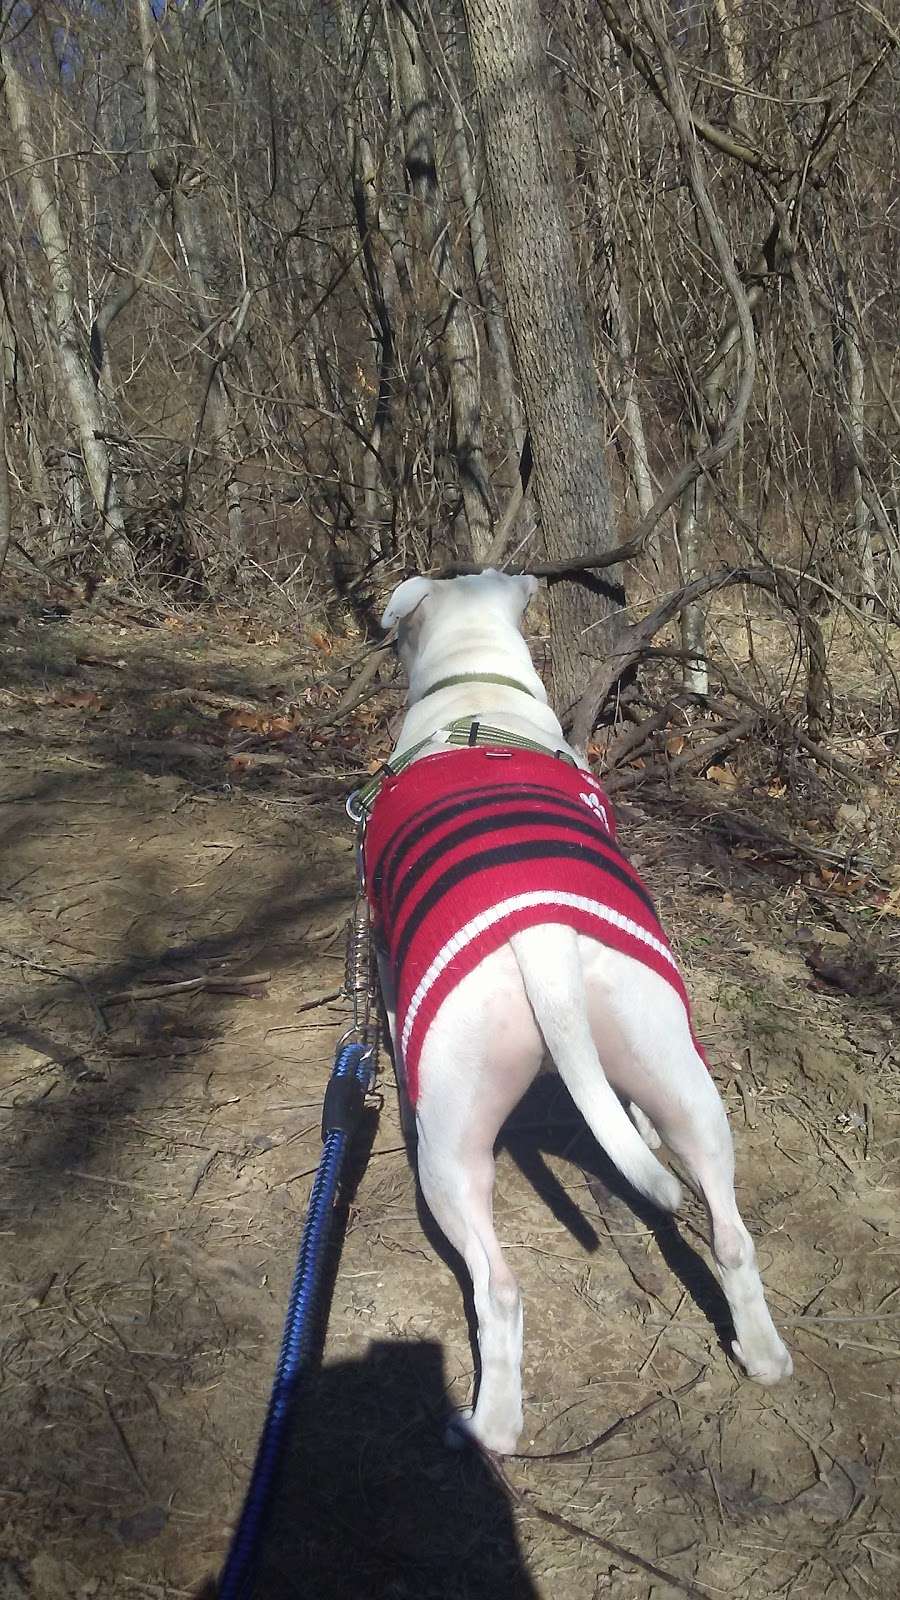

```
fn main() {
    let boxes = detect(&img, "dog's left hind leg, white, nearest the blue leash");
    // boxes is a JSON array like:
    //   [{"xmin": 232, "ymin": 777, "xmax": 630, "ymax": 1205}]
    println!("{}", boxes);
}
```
[{"xmin": 416, "ymin": 949, "xmax": 543, "ymax": 1454}]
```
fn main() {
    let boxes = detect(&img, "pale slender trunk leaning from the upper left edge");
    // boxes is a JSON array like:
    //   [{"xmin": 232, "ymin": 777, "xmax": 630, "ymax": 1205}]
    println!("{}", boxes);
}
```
[{"xmin": 0, "ymin": 50, "xmax": 135, "ymax": 578}]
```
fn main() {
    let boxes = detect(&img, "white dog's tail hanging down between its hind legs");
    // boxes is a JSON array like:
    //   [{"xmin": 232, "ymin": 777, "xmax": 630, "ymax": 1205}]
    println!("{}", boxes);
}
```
[{"xmin": 509, "ymin": 923, "xmax": 681, "ymax": 1211}]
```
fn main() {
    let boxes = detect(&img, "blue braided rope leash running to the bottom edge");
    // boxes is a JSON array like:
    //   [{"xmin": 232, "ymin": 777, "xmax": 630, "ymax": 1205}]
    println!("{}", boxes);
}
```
[{"xmin": 219, "ymin": 1043, "xmax": 375, "ymax": 1600}]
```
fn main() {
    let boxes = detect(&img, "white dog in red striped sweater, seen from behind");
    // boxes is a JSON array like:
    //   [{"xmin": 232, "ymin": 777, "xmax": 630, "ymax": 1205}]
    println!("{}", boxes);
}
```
[{"xmin": 365, "ymin": 571, "xmax": 791, "ymax": 1453}]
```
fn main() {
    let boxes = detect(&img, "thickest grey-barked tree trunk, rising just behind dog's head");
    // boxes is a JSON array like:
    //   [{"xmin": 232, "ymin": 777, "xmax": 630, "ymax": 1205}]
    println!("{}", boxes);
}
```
[{"xmin": 463, "ymin": 0, "xmax": 623, "ymax": 718}]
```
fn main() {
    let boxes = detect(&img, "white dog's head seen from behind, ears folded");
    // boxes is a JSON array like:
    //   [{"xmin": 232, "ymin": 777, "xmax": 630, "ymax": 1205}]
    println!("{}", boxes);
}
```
[{"xmin": 381, "ymin": 566, "xmax": 538, "ymax": 674}]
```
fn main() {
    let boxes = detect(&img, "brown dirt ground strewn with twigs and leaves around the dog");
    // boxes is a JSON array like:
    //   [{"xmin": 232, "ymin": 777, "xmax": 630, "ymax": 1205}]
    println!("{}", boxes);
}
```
[{"xmin": 0, "ymin": 579, "xmax": 900, "ymax": 1600}]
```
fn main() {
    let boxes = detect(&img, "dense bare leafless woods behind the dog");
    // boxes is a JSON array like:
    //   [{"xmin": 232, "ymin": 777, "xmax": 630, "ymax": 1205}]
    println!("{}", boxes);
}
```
[{"xmin": 0, "ymin": 0, "xmax": 900, "ymax": 741}]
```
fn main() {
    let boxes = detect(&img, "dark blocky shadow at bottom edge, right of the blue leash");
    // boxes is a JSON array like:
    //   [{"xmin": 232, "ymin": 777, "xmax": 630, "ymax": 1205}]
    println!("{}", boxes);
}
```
[{"xmin": 253, "ymin": 1339, "xmax": 536, "ymax": 1600}]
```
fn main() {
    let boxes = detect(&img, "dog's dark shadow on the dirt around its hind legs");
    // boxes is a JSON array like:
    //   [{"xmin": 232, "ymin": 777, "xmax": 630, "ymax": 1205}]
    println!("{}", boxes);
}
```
[{"xmin": 407, "ymin": 1074, "xmax": 735, "ymax": 1365}]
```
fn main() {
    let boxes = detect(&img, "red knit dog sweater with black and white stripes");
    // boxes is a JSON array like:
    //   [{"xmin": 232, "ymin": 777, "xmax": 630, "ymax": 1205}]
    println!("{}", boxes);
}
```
[{"xmin": 364, "ymin": 747, "xmax": 690, "ymax": 1104}]
